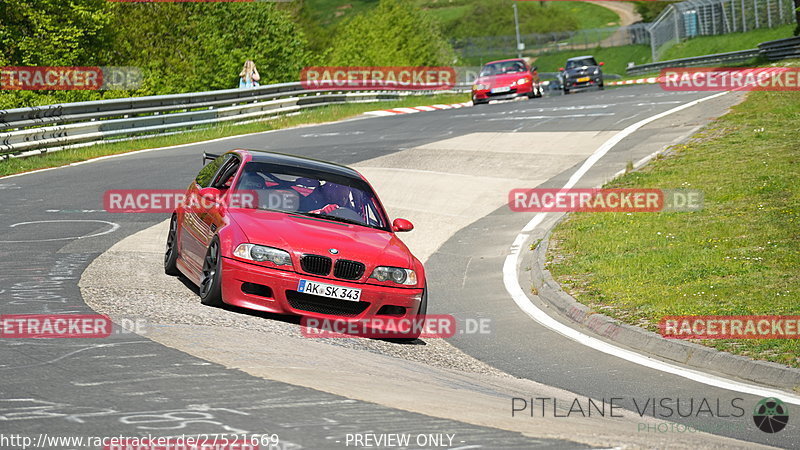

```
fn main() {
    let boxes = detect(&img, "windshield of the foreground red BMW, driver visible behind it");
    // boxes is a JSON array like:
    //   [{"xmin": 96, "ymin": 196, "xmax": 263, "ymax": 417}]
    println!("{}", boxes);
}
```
[{"xmin": 234, "ymin": 162, "xmax": 387, "ymax": 230}]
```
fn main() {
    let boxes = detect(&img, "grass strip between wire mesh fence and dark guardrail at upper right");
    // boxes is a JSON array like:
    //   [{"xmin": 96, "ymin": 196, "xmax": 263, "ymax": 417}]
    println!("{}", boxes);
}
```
[{"xmin": 661, "ymin": 25, "xmax": 794, "ymax": 61}]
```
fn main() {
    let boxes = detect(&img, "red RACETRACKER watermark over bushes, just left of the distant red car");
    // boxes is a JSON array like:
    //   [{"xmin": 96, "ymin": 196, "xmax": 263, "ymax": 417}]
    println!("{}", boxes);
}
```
[{"xmin": 300, "ymin": 66, "xmax": 456, "ymax": 90}]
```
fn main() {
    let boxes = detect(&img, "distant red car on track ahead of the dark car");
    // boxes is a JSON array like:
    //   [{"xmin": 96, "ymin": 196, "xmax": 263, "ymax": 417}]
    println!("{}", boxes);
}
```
[{"xmin": 472, "ymin": 59, "xmax": 542, "ymax": 105}]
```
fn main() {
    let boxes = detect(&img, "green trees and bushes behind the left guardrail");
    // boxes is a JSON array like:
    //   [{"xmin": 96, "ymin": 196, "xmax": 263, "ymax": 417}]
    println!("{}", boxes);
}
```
[{"xmin": 0, "ymin": 0, "xmax": 454, "ymax": 108}]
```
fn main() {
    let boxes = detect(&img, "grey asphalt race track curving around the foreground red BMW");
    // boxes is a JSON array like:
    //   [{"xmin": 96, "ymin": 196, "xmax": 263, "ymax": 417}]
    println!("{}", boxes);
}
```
[{"xmin": 0, "ymin": 86, "xmax": 800, "ymax": 449}]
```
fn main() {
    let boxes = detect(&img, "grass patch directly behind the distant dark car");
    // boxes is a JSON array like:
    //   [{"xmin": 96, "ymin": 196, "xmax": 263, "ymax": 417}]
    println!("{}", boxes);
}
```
[{"xmin": 533, "ymin": 45, "xmax": 650, "ymax": 75}]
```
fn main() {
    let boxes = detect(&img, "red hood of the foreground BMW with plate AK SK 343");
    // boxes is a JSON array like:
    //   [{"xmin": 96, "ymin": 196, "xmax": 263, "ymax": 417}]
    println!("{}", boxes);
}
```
[{"xmin": 229, "ymin": 209, "xmax": 413, "ymax": 267}]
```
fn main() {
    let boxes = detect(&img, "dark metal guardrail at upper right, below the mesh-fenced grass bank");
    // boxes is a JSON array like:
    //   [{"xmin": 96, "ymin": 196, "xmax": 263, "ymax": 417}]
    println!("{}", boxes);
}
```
[{"xmin": 626, "ymin": 37, "xmax": 800, "ymax": 75}]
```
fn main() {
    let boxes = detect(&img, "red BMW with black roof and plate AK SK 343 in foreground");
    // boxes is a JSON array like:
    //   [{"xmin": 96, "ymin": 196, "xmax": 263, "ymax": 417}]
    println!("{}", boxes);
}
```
[{"xmin": 164, "ymin": 150, "xmax": 427, "ymax": 339}]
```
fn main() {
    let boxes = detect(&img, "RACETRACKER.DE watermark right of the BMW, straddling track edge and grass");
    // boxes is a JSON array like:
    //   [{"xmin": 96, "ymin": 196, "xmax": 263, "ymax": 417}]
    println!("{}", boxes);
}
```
[{"xmin": 508, "ymin": 188, "xmax": 703, "ymax": 212}]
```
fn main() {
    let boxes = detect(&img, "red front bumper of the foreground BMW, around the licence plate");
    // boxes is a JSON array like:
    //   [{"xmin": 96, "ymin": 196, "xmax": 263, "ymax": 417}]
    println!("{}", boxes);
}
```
[{"xmin": 222, "ymin": 258, "xmax": 423, "ymax": 330}]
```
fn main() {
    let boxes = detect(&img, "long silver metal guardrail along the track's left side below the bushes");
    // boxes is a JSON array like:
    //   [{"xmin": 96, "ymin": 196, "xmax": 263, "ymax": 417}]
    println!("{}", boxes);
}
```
[{"xmin": 0, "ymin": 83, "xmax": 471, "ymax": 160}]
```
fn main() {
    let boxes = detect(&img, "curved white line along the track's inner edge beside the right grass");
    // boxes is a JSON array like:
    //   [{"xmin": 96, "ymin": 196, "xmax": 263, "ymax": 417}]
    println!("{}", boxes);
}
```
[{"xmin": 503, "ymin": 92, "xmax": 800, "ymax": 405}]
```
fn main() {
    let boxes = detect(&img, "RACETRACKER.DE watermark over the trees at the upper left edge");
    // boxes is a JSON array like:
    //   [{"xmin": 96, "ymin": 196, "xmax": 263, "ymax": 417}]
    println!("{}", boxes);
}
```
[{"xmin": 0, "ymin": 66, "xmax": 142, "ymax": 91}]
